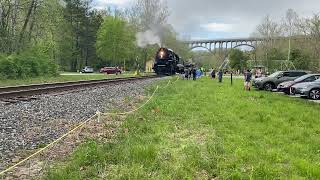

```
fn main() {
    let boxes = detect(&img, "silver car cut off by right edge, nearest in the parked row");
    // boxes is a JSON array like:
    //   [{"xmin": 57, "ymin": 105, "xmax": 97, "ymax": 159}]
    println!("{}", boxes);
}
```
[{"xmin": 291, "ymin": 79, "xmax": 320, "ymax": 100}]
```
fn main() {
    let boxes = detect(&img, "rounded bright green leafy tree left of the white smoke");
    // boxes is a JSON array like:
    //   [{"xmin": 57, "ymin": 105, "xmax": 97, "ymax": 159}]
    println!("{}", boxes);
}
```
[{"xmin": 96, "ymin": 16, "xmax": 135, "ymax": 65}]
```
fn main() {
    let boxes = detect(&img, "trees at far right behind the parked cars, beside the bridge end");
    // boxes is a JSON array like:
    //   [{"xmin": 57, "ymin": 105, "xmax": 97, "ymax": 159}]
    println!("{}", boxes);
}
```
[{"xmin": 252, "ymin": 9, "xmax": 320, "ymax": 72}]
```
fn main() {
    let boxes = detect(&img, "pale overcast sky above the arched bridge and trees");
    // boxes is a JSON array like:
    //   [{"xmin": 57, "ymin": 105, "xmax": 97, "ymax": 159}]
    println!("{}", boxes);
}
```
[{"xmin": 95, "ymin": 0, "xmax": 320, "ymax": 39}]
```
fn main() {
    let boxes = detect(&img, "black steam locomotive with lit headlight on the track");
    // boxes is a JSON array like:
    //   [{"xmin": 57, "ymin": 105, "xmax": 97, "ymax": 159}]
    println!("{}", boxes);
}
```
[{"xmin": 153, "ymin": 48, "xmax": 184, "ymax": 75}]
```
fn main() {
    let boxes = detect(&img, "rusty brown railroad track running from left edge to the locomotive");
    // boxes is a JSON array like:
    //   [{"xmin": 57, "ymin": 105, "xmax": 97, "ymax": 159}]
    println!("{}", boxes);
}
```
[{"xmin": 0, "ymin": 75, "xmax": 159, "ymax": 104}]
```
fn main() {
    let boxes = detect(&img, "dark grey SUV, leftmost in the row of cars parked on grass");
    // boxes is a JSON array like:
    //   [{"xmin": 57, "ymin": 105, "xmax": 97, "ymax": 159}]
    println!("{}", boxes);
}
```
[{"xmin": 253, "ymin": 71, "xmax": 308, "ymax": 91}]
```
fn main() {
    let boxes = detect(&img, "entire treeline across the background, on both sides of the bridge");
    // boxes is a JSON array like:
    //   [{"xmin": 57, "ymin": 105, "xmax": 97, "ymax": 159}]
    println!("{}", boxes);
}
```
[{"xmin": 0, "ymin": 0, "xmax": 320, "ymax": 79}]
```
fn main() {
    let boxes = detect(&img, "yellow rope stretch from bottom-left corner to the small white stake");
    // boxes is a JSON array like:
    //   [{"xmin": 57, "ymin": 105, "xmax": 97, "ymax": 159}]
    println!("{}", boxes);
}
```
[{"xmin": 0, "ymin": 114, "xmax": 97, "ymax": 176}]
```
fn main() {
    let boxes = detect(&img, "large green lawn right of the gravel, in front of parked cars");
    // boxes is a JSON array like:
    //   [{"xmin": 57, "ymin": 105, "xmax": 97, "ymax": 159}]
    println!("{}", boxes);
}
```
[{"xmin": 46, "ymin": 79, "xmax": 320, "ymax": 179}]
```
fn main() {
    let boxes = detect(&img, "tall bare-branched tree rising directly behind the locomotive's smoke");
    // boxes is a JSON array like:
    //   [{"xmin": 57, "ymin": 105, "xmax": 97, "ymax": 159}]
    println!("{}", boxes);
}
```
[{"xmin": 125, "ymin": 0, "xmax": 190, "ymax": 68}]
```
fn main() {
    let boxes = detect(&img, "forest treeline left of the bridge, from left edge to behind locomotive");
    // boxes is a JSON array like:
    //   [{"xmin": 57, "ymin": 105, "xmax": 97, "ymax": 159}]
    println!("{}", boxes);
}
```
[{"xmin": 0, "ymin": 0, "xmax": 187, "ymax": 78}]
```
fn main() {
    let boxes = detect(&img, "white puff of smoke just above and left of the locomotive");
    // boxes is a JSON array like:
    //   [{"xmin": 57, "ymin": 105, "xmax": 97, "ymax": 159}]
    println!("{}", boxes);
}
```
[{"xmin": 136, "ymin": 29, "xmax": 161, "ymax": 48}]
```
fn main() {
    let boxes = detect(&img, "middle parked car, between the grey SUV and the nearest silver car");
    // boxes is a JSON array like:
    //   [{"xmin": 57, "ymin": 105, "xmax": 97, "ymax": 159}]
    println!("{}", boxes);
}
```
[{"xmin": 277, "ymin": 74, "xmax": 320, "ymax": 94}]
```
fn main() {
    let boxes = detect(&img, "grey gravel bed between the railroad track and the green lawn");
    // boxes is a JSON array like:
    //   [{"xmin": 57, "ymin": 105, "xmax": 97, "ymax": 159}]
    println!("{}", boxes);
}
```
[{"xmin": 0, "ymin": 78, "xmax": 164, "ymax": 170}]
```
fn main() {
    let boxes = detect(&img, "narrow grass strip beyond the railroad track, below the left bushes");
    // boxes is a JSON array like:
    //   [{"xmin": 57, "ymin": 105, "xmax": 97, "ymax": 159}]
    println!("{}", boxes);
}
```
[{"xmin": 0, "ymin": 73, "xmax": 133, "ymax": 87}]
